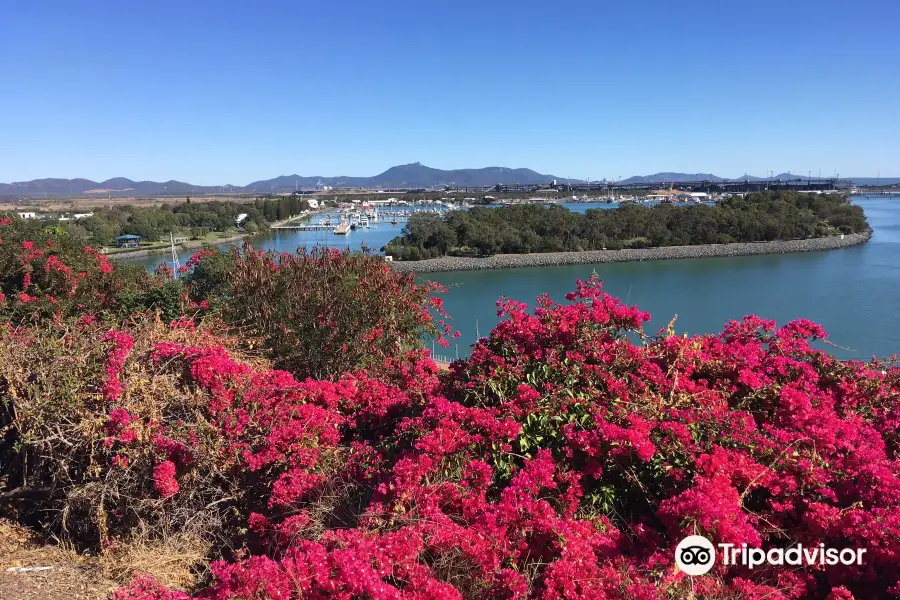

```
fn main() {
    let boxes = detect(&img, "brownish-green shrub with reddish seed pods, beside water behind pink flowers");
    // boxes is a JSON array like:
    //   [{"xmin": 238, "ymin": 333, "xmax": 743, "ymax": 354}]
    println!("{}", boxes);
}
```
[{"xmin": 188, "ymin": 246, "xmax": 449, "ymax": 378}]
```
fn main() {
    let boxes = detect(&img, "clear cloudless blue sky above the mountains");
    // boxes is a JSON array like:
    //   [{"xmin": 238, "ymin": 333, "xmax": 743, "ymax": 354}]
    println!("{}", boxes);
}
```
[{"xmin": 0, "ymin": 0, "xmax": 900, "ymax": 185}]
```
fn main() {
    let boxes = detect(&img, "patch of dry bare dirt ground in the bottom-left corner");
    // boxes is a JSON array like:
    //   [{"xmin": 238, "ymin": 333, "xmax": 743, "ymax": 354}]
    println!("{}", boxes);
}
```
[{"xmin": 0, "ymin": 521, "xmax": 117, "ymax": 600}]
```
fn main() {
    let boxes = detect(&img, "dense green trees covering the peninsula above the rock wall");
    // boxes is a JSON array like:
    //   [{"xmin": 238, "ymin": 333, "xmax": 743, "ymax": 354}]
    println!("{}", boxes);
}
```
[{"xmin": 384, "ymin": 191, "xmax": 869, "ymax": 260}]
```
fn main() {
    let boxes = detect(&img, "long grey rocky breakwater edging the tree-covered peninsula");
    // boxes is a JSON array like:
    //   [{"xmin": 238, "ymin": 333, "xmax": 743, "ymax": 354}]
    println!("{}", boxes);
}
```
[{"xmin": 391, "ymin": 232, "xmax": 872, "ymax": 273}]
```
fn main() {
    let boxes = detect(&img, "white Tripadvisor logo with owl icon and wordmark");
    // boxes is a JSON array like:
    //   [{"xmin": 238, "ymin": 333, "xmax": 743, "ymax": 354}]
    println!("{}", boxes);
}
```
[{"xmin": 675, "ymin": 535, "xmax": 866, "ymax": 575}]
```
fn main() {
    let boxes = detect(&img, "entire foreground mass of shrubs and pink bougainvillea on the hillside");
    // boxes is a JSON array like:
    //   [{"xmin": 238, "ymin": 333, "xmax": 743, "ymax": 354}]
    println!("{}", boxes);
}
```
[{"xmin": 0, "ymin": 219, "xmax": 900, "ymax": 600}]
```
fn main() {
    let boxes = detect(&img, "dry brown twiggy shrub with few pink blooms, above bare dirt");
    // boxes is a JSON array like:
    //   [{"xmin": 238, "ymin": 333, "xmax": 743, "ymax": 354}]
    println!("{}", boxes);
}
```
[{"xmin": 0, "ymin": 318, "xmax": 253, "ymax": 551}]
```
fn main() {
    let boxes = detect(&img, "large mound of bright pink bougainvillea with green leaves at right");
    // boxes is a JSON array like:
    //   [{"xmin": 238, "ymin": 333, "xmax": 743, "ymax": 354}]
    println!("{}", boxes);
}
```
[{"xmin": 438, "ymin": 284, "xmax": 900, "ymax": 598}]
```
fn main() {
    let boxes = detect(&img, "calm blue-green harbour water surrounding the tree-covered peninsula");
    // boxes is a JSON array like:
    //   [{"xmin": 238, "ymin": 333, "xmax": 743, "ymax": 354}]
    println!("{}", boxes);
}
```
[{"xmin": 125, "ymin": 198, "xmax": 900, "ymax": 360}]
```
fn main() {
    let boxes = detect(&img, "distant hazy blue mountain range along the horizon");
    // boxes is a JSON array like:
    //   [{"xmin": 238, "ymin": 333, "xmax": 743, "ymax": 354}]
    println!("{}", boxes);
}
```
[{"xmin": 0, "ymin": 163, "xmax": 900, "ymax": 197}]
